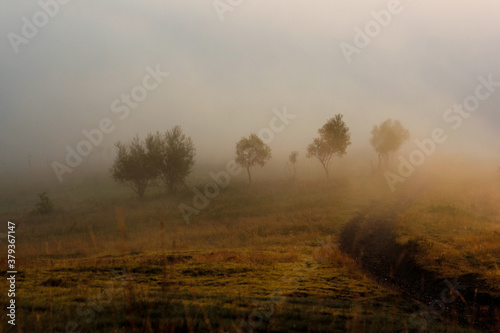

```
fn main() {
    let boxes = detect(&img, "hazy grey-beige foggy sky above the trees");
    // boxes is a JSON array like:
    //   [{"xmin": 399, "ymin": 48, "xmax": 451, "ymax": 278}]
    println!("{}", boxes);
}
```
[{"xmin": 0, "ymin": 0, "xmax": 500, "ymax": 182}]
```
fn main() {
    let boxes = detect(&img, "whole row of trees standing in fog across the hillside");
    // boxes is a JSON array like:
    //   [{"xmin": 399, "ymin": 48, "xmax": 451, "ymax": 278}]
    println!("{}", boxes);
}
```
[{"xmin": 110, "ymin": 114, "xmax": 410, "ymax": 198}]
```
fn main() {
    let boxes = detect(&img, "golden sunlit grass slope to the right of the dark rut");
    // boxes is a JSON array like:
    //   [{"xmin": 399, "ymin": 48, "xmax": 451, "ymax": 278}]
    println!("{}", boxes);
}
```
[{"xmin": 396, "ymin": 172, "xmax": 500, "ymax": 293}]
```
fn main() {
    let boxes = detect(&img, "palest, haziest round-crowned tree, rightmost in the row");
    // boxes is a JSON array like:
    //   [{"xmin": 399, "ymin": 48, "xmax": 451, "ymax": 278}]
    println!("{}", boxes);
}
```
[{"xmin": 370, "ymin": 119, "xmax": 410, "ymax": 170}]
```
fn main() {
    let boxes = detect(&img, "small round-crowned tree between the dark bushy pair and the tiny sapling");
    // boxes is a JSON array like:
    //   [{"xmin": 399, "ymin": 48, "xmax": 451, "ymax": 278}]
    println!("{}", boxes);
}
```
[{"xmin": 236, "ymin": 133, "xmax": 271, "ymax": 184}]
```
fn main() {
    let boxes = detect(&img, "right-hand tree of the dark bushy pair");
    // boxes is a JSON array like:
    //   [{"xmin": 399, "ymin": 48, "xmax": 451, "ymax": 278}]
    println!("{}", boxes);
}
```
[{"xmin": 146, "ymin": 126, "xmax": 196, "ymax": 193}]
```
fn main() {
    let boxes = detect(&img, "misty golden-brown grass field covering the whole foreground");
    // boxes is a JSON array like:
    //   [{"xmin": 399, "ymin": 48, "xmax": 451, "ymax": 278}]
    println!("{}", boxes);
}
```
[{"xmin": 0, "ymin": 172, "xmax": 500, "ymax": 332}]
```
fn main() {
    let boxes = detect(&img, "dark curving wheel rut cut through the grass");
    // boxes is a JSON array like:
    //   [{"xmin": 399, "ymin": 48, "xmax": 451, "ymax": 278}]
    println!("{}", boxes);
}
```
[{"xmin": 340, "ymin": 204, "xmax": 500, "ymax": 332}]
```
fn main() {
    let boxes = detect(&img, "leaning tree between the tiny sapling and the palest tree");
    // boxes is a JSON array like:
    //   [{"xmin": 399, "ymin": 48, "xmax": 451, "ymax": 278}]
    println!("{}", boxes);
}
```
[{"xmin": 307, "ymin": 114, "xmax": 351, "ymax": 178}]
